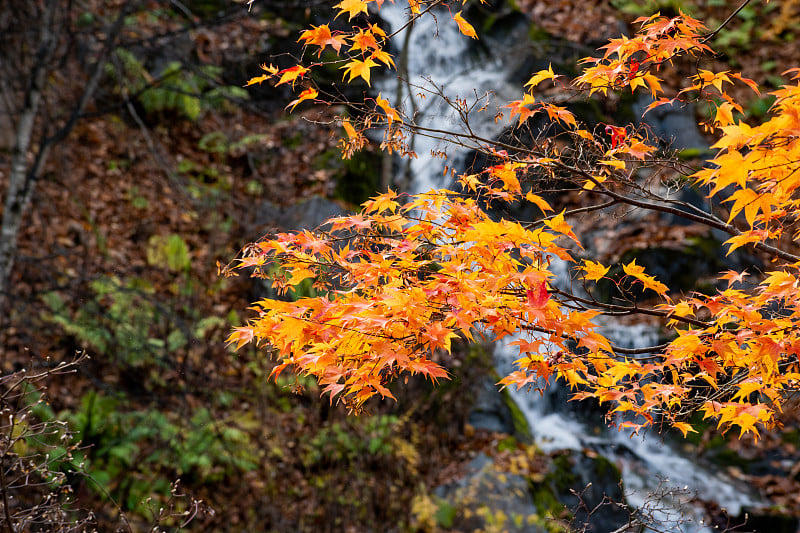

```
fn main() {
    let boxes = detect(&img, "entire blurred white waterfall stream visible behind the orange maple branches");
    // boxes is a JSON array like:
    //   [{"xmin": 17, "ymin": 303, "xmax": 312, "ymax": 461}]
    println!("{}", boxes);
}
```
[{"xmin": 376, "ymin": 2, "xmax": 761, "ymax": 532}]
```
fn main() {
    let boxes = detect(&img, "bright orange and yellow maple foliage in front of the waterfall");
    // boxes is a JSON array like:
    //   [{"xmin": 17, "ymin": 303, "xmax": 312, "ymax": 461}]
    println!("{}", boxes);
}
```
[{"xmin": 229, "ymin": 0, "xmax": 800, "ymax": 436}]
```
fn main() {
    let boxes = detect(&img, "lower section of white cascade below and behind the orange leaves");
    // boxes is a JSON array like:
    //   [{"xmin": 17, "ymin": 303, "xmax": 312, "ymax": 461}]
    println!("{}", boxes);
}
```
[{"xmin": 495, "ymin": 260, "xmax": 761, "ymax": 533}]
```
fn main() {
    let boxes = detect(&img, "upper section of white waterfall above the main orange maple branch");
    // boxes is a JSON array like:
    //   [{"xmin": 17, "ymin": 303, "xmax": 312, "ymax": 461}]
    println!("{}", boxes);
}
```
[{"xmin": 376, "ymin": 2, "xmax": 522, "ymax": 193}]
